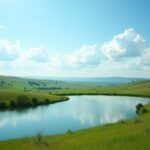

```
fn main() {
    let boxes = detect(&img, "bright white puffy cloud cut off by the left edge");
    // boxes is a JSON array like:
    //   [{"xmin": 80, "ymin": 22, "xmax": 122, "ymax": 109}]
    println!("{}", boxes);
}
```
[{"xmin": 0, "ymin": 40, "xmax": 20, "ymax": 61}]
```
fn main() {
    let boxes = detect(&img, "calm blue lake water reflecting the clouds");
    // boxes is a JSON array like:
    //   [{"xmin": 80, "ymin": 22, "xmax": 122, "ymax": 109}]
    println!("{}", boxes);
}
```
[{"xmin": 0, "ymin": 96, "xmax": 149, "ymax": 140}]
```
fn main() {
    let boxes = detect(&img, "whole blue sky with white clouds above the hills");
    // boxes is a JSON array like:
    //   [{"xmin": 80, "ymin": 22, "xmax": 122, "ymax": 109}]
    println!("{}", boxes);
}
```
[{"xmin": 0, "ymin": 0, "xmax": 150, "ymax": 78}]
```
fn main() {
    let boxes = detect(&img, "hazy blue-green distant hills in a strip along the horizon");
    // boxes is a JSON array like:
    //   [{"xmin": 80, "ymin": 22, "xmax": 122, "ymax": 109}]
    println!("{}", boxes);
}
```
[{"xmin": 0, "ymin": 75, "xmax": 148, "ymax": 89}]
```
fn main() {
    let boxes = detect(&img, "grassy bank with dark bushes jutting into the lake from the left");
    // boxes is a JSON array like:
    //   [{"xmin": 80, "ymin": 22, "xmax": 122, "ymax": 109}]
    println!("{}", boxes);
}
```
[{"xmin": 0, "ymin": 89, "xmax": 69, "ymax": 110}]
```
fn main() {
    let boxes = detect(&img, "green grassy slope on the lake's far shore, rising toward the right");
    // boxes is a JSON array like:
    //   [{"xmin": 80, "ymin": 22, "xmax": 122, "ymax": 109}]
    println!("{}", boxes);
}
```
[{"xmin": 53, "ymin": 81, "xmax": 150, "ymax": 97}]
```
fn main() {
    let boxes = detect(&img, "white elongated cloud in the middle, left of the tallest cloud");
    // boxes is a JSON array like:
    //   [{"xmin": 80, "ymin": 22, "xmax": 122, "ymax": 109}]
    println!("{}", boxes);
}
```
[{"xmin": 50, "ymin": 45, "xmax": 101, "ymax": 69}]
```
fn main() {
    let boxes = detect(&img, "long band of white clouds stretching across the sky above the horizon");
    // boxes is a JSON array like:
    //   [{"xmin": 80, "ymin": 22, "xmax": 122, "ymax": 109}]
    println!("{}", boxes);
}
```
[{"xmin": 0, "ymin": 28, "xmax": 150, "ymax": 76}]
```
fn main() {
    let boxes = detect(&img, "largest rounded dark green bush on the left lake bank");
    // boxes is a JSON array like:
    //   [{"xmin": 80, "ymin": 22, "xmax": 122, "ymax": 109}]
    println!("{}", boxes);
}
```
[{"xmin": 17, "ymin": 95, "xmax": 31, "ymax": 107}]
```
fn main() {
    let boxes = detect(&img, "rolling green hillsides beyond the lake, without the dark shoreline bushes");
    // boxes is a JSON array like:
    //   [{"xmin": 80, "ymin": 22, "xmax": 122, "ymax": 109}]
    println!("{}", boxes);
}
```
[{"xmin": 0, "ymin": 76, "xmax": 150, "ymax": 104}]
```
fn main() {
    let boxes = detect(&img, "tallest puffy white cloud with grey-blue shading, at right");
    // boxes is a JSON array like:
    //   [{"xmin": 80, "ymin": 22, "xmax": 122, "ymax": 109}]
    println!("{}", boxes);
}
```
[{"xmin": 101, "ymin": 28, "xmax": 145, "ymax": 60}]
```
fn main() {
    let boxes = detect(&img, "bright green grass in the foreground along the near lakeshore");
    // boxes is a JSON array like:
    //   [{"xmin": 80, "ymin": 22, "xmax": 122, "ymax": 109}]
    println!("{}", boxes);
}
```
[{"xmin": 0, "ymin": 104, "xmax": 150, "ymax": 150}]
